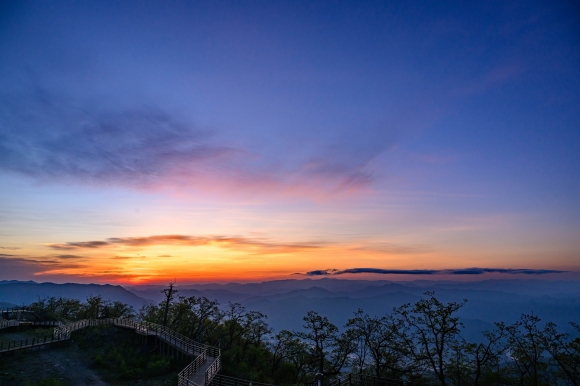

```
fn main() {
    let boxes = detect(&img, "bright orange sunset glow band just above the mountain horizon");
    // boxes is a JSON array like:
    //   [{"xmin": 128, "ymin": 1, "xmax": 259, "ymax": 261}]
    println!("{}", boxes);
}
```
[{"xmin": 4, "ymin": 231, "xmax": 569, "ymax": 284}]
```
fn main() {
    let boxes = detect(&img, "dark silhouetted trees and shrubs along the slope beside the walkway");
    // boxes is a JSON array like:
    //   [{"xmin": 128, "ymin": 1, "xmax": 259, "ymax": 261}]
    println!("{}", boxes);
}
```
[{"xmin": 4, "ymin": 285, "xmax": 580, "ymax": 386}]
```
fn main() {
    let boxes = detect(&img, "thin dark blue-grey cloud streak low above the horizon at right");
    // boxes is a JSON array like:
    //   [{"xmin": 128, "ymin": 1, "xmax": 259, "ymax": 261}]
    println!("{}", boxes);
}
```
[{"xmin": 303, "ymin": 268, "xmax": 568, "ymax": 276}]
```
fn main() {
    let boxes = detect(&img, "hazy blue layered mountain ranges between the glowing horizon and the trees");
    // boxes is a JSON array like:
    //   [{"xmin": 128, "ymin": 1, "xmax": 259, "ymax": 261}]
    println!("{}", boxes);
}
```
[{"xmin": 0, "ymin": 278, "xmax": 580, "ymax": 340}]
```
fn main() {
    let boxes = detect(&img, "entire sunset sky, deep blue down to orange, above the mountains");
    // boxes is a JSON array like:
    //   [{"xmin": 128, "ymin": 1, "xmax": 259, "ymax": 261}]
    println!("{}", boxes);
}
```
[{"xmin": 0, "ymin": 0, "xmax": 580, "ymax": 284}]
